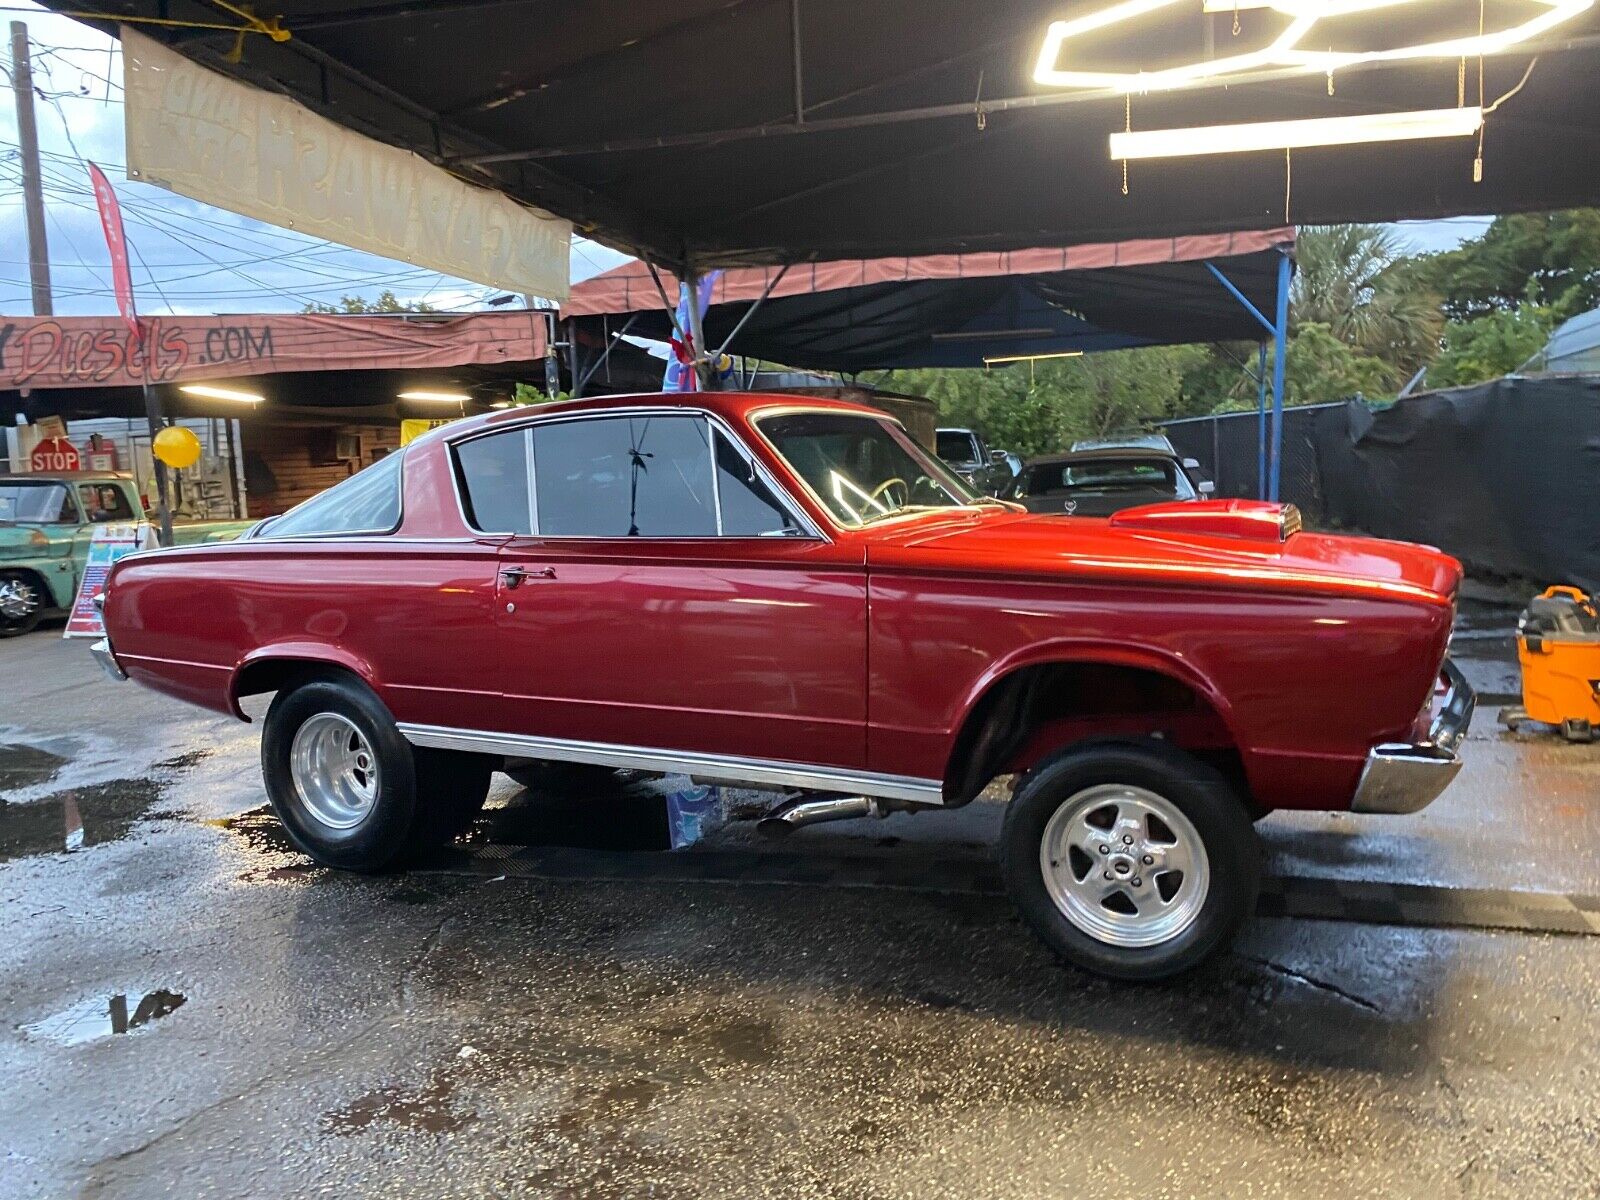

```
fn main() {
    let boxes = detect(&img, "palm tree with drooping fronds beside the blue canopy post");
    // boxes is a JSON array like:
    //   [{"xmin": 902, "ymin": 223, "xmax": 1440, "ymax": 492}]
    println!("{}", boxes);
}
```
[{"xmin": 1290, "ymin": 226, "xmax": 1445, "ymax": 382}]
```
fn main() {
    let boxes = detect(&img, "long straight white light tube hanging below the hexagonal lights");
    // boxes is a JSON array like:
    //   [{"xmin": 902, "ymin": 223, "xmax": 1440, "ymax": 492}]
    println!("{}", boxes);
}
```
[{"xmin": 1110, "ymin": 107, "xmax": 1483, "ymax": 158}]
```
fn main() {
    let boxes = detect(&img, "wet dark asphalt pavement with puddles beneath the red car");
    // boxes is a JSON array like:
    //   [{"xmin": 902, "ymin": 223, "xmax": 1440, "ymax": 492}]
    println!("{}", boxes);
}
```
[{"xmin": 0, "ymin": 608, "xmax": 1600, "ymax": 1200}]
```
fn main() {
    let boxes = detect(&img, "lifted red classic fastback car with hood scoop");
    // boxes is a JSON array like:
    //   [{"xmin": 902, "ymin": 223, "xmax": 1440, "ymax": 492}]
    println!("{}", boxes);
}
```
[{"xmin": 96, "ymin": 394, "xmax": 1474, "ymax": 978}]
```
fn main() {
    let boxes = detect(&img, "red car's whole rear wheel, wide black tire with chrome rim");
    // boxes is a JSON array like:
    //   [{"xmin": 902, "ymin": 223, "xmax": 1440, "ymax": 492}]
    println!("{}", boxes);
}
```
[{"xmin": 261, "ymin": 677, "xmax": 490, "ymax": 870}]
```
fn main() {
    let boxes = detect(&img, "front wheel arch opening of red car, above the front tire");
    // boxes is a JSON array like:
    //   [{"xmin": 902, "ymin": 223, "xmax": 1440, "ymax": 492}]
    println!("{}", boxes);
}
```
[{"xmin": 944, "ymin": 640, "xmax": 1248, "ymax": 805}]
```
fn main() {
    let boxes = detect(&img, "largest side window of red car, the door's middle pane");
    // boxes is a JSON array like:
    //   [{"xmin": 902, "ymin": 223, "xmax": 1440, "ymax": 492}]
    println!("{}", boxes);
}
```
[{"xmin": 533, "ymin": 414, "xmax": 717, "ymax": 538}]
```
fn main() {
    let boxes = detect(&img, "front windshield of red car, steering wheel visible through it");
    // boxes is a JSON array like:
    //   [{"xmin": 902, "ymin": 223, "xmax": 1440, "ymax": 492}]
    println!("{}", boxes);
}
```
[{"xmin": 757, "ymin": 413, "xmax": 978, "ymax": 526}]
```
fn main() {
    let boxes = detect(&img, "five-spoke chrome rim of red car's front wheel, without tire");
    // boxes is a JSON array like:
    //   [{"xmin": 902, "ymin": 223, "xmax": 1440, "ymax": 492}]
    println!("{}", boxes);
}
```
[{"xmin": 1038, "ymin": 784, "xmax": 1211, "ymax": 949}]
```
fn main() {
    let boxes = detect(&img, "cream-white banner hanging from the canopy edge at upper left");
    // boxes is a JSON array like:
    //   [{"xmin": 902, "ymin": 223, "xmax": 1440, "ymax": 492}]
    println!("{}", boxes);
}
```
[{"xmin": 122, "ymin": 26, "xmax": 573, "ymax": 301}]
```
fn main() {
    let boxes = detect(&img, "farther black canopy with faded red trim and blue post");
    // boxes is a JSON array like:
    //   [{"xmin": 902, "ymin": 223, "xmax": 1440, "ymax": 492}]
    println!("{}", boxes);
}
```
[{"xmin": 563, "ymin": 227, "xmax": 1294, "ymax": 498}]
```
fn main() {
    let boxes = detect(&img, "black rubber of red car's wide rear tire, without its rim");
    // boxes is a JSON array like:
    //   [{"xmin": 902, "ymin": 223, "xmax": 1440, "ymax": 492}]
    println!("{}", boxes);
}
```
[{"xmin": 261, "ymin": 677, "xmax": 490, "ymax": 872}]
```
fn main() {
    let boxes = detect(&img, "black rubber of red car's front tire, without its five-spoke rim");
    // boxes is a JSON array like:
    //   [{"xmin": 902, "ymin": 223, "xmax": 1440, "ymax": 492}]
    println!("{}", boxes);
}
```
[{"xmin": 1000, "ymin": 741, "xmax": 1261, "ymax": 982}]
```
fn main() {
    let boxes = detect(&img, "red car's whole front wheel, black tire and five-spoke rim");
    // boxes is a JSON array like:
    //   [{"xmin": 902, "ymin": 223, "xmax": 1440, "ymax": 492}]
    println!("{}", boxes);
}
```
[{"xmin": 1000, "ymin": 742, "xmax": 1261, "ymax": 981}]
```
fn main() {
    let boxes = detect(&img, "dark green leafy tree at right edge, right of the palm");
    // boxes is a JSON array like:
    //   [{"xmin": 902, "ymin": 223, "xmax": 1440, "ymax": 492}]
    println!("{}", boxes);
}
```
[{"xmin": 1416, "ymin": 208, "xmax": 1600, "ymax": 325}]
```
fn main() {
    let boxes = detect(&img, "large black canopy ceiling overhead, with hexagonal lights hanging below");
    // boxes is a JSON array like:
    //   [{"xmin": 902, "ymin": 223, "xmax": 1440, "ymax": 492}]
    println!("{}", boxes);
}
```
[{"xmin": 34, "ymin": 0, "xmax": 1600, "ymax": 269}]
